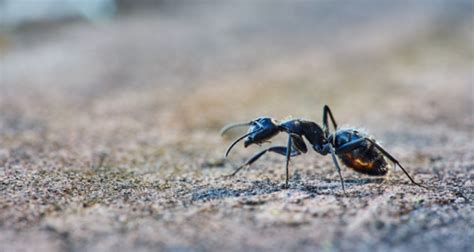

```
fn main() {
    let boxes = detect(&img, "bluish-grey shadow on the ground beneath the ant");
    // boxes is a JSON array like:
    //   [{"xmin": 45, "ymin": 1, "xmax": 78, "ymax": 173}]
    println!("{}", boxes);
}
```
[{"xmin": 191, "ymin": 175, "xmax": 385, "ymax": 201}]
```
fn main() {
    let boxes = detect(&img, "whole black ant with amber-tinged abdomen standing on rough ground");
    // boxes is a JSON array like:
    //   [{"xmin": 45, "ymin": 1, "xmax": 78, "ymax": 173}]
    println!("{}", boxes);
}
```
[{"xmin": 221, "ymin": 105, "xmax": 426, "ymax": 192}]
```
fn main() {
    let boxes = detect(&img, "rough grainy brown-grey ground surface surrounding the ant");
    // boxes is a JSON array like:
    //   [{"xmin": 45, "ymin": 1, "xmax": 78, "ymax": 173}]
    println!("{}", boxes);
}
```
[{"xmin": 0, "ymin": 1, "xmax": 474, "ymax": 251}]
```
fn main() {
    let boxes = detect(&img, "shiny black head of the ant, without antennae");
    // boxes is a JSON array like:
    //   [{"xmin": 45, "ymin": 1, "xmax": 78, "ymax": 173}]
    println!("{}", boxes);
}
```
[{"xmin": 244, "ymin": 117, "xmax": 280, "ymax": 147}]
